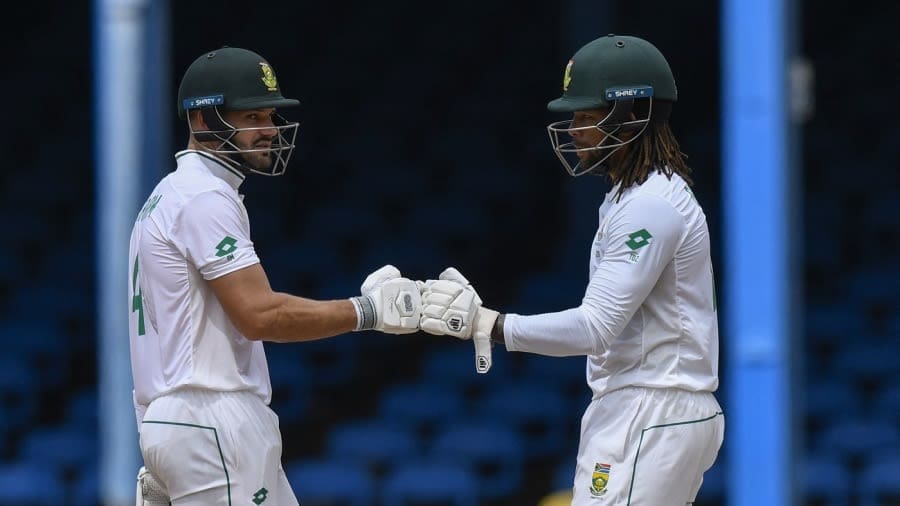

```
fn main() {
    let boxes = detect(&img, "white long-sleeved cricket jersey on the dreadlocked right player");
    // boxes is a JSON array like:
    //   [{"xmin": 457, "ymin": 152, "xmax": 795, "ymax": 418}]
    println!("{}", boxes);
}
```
[{"xmin": 504, "ymin": 172, "xmax": 719, "ymax": 398}]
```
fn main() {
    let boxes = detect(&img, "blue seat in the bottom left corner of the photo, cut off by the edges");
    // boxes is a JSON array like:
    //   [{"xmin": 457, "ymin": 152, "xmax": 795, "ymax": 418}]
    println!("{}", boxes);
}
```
[{"xmin": 0, "ymin": 463, "xmax": 66, "ymax": 506}]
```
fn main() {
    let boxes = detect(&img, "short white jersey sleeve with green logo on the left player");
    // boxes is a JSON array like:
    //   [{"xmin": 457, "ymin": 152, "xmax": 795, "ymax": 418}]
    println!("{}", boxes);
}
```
[{"xmin": 172, "ymin": 191, "xmax": 259, "ymax": 280}]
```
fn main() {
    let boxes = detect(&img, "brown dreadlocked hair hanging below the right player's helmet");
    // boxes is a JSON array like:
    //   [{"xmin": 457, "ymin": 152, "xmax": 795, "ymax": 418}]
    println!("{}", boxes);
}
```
[{"xmin": 613, "ymin": 120, "xmax": 694, "ymax": 201}]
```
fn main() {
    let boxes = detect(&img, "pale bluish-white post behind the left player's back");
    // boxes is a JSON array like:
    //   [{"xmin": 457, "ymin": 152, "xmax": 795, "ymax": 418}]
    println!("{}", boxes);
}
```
[{"xmin": 94, "ymin": 0, "xmax": 146, "ymax": 506}]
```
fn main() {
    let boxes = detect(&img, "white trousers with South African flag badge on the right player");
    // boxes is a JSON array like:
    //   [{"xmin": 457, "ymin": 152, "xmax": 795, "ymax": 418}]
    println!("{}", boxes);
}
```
[{"xmin": 572, "ymin": 387, "xmax": 725, "ymax": 506}]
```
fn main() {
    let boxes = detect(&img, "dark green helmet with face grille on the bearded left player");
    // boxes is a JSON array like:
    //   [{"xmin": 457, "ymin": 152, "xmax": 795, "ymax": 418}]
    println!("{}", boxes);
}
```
[{"xmin": 178, "ymin": 47, "xmax": 300, "ymax": 176}]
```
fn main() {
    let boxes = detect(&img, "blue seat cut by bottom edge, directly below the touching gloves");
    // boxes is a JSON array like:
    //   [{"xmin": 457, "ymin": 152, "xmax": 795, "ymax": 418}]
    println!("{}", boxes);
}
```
[{"xmin": 381, "ymin": 459, "xmax": 479, "ymax": 506}]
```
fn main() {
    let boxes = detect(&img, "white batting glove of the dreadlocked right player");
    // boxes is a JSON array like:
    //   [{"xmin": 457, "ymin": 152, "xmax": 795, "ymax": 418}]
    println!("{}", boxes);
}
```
[{"xmin": 419, "ymin": 267, "xmax": 499, "ymax": 374}]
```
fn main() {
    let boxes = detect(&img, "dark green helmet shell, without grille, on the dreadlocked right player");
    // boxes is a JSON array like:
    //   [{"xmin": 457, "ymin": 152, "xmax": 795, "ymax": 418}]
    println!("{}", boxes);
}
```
[{"xmin": 547, "ymin": 34, "xmax": 678, "ymax": 112}]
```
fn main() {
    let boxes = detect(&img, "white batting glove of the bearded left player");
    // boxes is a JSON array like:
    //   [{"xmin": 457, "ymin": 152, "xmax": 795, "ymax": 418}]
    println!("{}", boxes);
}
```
[{"xmin": 350, "ymin": 265, "xmax": 422, "ymax": 334}]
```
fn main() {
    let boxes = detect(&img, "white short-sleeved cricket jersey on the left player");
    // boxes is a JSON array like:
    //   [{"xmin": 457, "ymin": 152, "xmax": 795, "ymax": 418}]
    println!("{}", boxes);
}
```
[{"xmin": 128, "ymin": 150, "xmax": 271, "ymax": 425}]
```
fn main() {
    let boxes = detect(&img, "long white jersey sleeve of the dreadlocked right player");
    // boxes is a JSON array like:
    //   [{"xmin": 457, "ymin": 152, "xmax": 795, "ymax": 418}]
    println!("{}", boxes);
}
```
[{"xmin": 504, "ymin": 195, "xmax": 684, "ymax": 356}]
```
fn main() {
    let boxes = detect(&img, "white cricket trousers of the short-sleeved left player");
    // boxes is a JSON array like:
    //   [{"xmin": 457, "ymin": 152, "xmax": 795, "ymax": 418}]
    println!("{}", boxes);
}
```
[{"xmin": 140, "ymin": 389, "xmax": 297, "ymax": 506}]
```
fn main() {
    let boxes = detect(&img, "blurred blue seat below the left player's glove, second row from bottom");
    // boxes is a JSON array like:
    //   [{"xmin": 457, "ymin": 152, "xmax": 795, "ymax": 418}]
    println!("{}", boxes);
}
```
[{"xmin": 325, "ymin": 420, "xmax": 420, "ymax": 475}]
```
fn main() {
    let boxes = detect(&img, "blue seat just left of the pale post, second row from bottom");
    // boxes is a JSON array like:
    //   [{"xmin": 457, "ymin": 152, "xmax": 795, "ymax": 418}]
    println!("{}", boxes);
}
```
[{"xmin": 19, "ymin": 426, "xmax": 99, "ymax": 475}]
